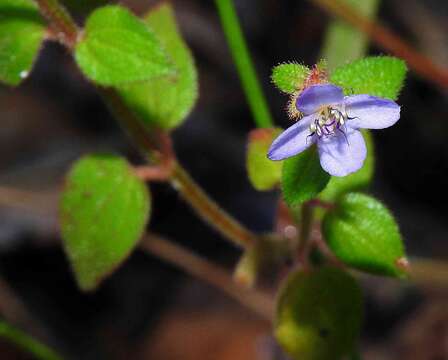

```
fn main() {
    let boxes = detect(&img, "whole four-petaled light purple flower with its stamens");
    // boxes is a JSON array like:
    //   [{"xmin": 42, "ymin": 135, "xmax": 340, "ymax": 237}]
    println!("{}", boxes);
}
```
[{"xmin": 268, "ymin": 84, "xmax": 400, "ymax": 176}]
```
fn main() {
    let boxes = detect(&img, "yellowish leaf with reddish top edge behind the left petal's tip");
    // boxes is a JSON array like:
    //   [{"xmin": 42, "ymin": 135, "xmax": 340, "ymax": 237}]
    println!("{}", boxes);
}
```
[{"xmin": 246, "ymin": 128, "xmax": 283, "ymax": 191}]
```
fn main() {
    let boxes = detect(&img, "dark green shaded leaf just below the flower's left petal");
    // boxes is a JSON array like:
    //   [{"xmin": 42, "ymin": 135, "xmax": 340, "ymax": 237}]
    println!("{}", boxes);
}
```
[{"xmin": 282, "ymin": 146, "xmax": 330, "ymax": 206}]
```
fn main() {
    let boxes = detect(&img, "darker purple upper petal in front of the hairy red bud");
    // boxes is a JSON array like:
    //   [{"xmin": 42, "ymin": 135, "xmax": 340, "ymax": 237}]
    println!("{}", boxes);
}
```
[{"xmin": 296, "ymin": 84, "xmax": 344, "ymax": 115}]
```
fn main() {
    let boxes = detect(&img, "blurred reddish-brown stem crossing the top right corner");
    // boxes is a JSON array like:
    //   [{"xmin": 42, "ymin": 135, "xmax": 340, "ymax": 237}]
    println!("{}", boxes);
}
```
[{"xmin": 312, "ymin": 0, "xmax": 448, "ymax": 89}]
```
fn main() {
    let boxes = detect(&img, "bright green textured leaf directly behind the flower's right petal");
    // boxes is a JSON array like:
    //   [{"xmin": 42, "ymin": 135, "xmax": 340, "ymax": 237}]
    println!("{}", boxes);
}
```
[{"xmin": 330, "ymin": 56, "xmax": 407, "ymax": 100}]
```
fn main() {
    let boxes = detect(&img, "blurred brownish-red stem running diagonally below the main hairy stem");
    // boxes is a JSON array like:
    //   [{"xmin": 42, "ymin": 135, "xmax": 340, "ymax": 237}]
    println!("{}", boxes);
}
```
[{"xmin": 141, "ymin": 234, "xmax": 274, "ymax": 321}]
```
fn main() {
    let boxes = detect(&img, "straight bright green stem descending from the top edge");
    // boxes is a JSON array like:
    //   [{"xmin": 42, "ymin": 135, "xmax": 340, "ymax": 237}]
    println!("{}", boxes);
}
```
[{"xmin": 215, "ymin": 0, "xmax": 273, "ymax": 128}]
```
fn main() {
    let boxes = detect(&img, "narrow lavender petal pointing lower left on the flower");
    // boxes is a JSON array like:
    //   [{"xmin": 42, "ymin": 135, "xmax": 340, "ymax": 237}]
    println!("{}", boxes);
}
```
[{"xmin": 268, "ymin": 116, "xmax": 314, "ymax": 160}]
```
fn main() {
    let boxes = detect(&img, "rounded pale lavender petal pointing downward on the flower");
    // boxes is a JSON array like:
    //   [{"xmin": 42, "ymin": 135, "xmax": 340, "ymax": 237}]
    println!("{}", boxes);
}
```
[{"xmin": 317, "ymin": 129, "xmax": 367, "ymax": 176}]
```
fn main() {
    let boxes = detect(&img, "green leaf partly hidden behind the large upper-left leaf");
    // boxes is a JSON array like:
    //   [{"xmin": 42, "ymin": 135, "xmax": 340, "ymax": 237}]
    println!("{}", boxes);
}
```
[{"xmin": 120, "ymin": 3, "xmax": 198, "ymax": 129}]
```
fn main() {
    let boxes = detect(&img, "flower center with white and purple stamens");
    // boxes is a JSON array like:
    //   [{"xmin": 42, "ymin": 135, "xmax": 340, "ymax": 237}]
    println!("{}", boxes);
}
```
[{"xmin": 309, "ymin": 106, "xmax": 348, "ymax": 138}]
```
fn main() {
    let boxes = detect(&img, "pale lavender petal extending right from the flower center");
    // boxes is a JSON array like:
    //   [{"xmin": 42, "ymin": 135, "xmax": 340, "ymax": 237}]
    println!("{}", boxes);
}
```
[{"xmin": 344, "ymin": 95, "xmax": 400, "ymax": 129}]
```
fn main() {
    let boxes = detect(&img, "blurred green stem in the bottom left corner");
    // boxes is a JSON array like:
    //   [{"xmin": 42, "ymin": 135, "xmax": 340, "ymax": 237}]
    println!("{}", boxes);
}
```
[{"xmin": 0, "ymin": 321, "xmax": 62, "ymax": 360}]
